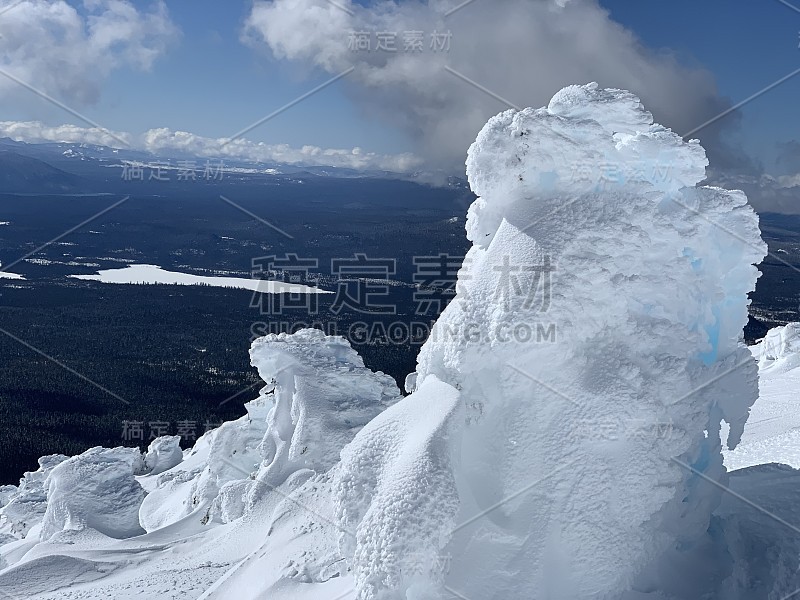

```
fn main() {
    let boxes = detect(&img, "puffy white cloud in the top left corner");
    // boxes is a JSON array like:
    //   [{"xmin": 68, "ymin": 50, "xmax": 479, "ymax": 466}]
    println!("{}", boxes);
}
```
[{"xmin": 0, "ymin": 0, "xmax": 179, "ymax": 104}]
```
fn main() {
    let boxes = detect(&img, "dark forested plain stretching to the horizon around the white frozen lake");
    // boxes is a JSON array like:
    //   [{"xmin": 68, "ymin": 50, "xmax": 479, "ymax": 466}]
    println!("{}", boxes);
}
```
[{"xmin": 0, "ymin": 179, "xmax": 800, "ymax": 484}]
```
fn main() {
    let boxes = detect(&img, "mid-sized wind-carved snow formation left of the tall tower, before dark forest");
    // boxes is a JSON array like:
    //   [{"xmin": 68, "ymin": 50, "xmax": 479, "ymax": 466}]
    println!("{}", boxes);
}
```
[{"xmin": 140, "ymin": 330, "xmax": 400, "ymax": 531}]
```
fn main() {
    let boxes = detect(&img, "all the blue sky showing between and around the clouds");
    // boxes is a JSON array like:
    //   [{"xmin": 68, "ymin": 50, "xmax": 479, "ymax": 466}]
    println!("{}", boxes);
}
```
[{"xmin": 0, "ymin": 0, "xmax": 800, "ymax": 173}]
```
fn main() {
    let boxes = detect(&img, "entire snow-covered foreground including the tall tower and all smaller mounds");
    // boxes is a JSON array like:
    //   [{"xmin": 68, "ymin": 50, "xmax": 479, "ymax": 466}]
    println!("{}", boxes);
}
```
[{"xmin": 0, "ymin": 84, "xmax": 800, "ymax": 600}]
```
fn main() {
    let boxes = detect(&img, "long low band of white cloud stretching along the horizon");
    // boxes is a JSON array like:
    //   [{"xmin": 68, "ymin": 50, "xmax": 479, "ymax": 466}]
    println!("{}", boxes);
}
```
[{"xmin": 0, "ymin": 121, "xmax": 422, "ymax": 173}]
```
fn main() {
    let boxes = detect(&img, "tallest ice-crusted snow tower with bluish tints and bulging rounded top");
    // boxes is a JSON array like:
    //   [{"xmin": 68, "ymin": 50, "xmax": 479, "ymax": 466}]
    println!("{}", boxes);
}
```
[{"xmin": 416, "ymin": 84, "xmax": 766, "ymax": 600}]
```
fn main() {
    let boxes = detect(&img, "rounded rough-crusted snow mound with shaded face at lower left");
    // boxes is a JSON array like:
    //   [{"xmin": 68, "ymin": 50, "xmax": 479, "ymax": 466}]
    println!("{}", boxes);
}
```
[{"xmin": 40, "ymin": 448, "xmax": 145, "ymax": 541}]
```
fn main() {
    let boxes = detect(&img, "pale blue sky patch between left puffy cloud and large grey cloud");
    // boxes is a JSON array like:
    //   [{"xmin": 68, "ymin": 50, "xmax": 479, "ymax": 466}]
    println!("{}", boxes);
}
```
[{"xmin": 93, "ymin": 0, "xmax": 409, "ymax": 152}]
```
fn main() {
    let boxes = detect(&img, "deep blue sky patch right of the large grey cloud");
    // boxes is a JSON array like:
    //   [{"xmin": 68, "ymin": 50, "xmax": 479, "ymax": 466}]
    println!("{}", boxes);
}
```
[{"xmin": 602, "ymin": 0, "xmax": 800, "ymax": 169}]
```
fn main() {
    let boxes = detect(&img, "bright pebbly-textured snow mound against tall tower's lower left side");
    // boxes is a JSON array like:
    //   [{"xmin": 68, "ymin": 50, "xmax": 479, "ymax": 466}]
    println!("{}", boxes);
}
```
[{"xmin": 334, "ymin": 377, "xmax": 461, "ymax": 600}]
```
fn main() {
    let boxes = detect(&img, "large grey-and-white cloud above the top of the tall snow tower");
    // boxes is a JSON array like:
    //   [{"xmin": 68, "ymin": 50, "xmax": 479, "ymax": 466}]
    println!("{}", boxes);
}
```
[{"xmin": 242, "ymin": 0, "xmax": 735, "ymax": 168}]
